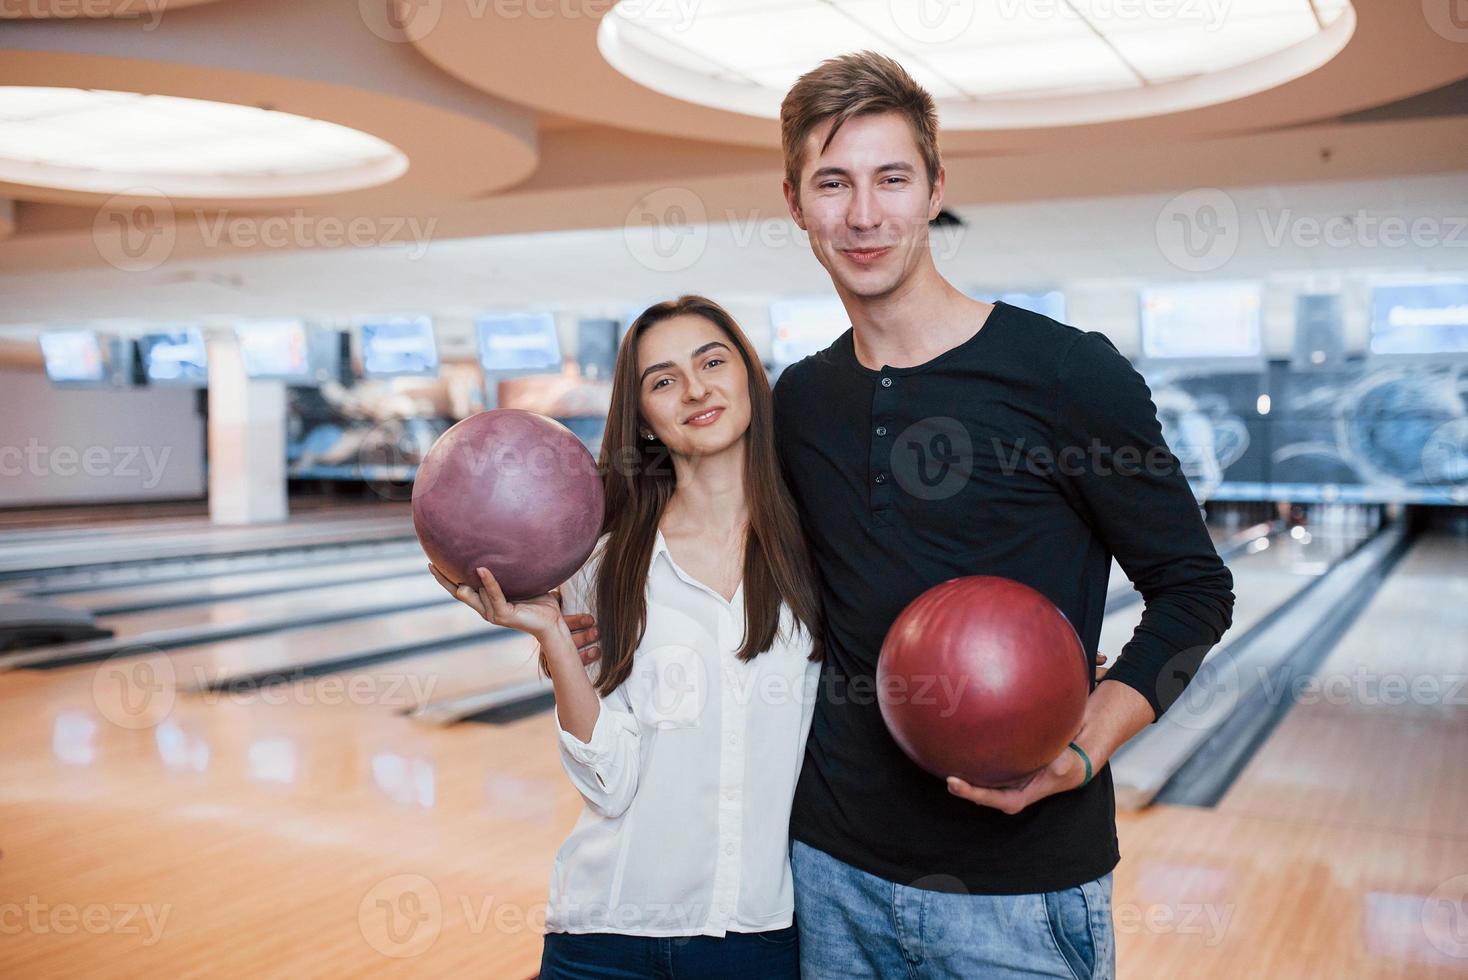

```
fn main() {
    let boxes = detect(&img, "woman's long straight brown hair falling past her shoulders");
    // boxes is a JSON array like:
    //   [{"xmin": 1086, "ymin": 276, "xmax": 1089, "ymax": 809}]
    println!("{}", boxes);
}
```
[{"xmin": 593, "ymin": 295, "xmax": 821, "ymax": 697}]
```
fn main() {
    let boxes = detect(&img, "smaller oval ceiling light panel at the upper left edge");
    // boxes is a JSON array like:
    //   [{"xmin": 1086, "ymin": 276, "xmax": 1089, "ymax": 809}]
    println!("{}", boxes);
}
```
[{"xmin": 0, "ymin": 85, "xmax": 408, "ymax": 200}]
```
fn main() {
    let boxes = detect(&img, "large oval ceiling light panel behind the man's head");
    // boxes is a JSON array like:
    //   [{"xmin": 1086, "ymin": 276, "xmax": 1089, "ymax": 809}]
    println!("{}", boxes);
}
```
[{"xmin": 597, "ymin": 0, "xmax": 1355, "ymax": 129}]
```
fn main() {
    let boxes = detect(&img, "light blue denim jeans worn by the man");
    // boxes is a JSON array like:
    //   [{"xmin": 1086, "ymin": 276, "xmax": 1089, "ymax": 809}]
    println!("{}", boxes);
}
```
[{"xmin": 790, "ymin": 841, "xmax": 1116, "ymax": 980}]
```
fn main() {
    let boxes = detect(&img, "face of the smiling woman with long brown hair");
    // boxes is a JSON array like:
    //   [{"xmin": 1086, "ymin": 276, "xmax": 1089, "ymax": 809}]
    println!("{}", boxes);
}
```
[{"xmin": 637, "ymin": 314, "xmax": 750, "ymax": 456}]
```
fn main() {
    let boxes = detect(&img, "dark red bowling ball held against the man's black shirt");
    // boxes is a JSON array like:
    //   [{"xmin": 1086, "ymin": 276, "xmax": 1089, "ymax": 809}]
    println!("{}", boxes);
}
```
[{"xmin": 876, "ymin": 575, "xmax": 1091, "ymax": 786}]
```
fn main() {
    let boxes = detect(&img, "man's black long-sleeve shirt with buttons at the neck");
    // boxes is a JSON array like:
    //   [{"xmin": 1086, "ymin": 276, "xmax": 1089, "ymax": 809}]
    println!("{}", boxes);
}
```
[{"xmin": 775, "ymin": 302, "xmax": 1233, "ymax": 893}]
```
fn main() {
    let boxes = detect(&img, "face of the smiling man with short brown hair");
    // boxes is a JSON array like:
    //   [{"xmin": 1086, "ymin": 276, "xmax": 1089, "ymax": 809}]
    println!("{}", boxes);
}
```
[{"xmin": 785, "ymin": 113, "xmax": 942, "ymax": 299}]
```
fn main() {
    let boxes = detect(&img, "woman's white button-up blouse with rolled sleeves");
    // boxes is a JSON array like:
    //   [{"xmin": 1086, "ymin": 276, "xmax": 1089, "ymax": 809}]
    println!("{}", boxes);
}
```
[{"xmin": 546, "ymin": 531, "xmax": 819, "ymax": 936}]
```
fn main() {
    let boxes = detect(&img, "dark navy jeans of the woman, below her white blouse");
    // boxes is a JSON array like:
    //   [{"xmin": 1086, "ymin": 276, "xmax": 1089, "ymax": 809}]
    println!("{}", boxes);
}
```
[{"xmin": 540, "ymin": 926, "xmax": 800, "ymax": 980}]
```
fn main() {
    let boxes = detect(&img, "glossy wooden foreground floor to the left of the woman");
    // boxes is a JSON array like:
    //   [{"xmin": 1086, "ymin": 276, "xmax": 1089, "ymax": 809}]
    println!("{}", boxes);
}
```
[{"xmin": 0, "ymin": 669, "xmax": 580, "ymax": 979}]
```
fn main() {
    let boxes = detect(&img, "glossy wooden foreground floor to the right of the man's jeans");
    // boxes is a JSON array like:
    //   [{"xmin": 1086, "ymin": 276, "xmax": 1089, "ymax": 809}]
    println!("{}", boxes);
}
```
[{"xmin": 1113, "ymin": 805, "xmax": 1468, "ymax": 980}]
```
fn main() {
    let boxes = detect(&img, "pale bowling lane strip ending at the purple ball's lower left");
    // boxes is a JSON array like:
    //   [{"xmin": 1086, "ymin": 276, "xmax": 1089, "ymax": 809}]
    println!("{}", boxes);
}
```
[{"xmin": 79, "ymin": 571, "xmax": 454, "ymax": 640}]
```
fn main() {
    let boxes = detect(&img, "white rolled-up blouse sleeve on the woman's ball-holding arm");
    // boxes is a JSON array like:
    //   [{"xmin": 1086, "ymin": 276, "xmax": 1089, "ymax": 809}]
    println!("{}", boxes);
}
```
[{"xmin": 555, "ymin": 557, "xmax": 642, "ymax": 817}]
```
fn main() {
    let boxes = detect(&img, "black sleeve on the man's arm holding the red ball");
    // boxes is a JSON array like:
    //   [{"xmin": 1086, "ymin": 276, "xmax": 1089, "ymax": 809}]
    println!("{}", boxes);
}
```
[{"xmin": 1055, "ymin": 332, "xmax": 1233, "ymax": 722}]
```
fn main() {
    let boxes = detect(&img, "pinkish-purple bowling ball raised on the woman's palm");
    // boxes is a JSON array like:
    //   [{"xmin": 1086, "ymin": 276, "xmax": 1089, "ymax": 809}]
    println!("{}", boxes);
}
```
[{"xmin": 413, "ymin": 408, "xmax": 603, "ymax": 600}]
